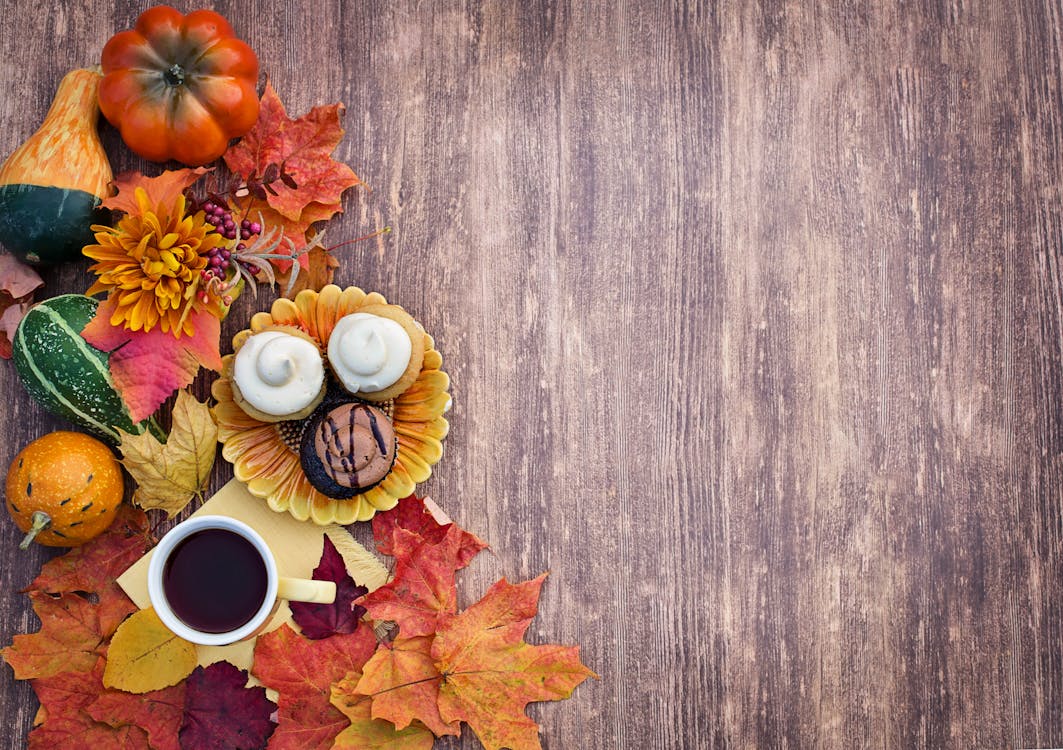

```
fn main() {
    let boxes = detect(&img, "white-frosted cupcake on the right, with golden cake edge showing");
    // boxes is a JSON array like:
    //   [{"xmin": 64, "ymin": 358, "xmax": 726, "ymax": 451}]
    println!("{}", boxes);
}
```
[{"xmin": 328, "ymin": 305, "xmax": 424, "ymax": 402}]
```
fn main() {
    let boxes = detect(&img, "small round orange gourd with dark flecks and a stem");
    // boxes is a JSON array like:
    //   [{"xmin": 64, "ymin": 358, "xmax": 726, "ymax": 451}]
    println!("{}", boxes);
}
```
[{"xmin": 6, "ymin": 431, "xmax": 123, "ymax": 549}]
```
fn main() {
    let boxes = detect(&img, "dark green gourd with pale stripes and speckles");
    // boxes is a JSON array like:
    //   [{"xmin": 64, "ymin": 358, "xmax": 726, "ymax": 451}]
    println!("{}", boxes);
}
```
[{"xmin": 12, "ymin": 294, "xmax": 163, "ymax": 444}]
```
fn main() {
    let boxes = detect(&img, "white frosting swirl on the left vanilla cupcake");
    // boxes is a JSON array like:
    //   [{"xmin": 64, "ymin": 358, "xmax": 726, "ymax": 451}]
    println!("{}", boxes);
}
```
[{"xmin": 233, "ymin": 330, "xmax": 325, "ymax": 416}]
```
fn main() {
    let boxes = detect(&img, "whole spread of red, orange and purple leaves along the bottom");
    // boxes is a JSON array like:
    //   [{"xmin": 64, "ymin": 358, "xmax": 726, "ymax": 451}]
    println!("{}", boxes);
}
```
[{"xmin": 2, "ymin": 496, "xmax": 593, "ymax": 750}]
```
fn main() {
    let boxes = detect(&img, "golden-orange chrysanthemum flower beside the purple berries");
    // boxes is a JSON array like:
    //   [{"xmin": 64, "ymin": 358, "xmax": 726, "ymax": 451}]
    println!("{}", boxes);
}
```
[{"xmin": 82, "ymin": 188, "xmax": 225, "ymax": 338}]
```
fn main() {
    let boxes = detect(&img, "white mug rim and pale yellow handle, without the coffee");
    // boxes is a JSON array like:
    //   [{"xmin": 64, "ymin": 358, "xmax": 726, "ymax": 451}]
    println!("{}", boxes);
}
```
[{"xmin": 148, "ymin": 515, "xmax": 336, "ymax": 646}]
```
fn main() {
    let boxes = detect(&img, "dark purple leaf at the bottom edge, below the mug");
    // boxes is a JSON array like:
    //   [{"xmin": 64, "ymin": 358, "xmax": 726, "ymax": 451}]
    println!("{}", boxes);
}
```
[{"xmin": 180, "ymin": 662, "xmax": 275, "ymax": 750}]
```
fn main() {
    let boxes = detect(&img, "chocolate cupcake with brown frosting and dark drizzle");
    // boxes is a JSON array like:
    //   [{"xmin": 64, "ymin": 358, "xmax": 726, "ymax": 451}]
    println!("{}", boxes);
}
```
[{"xmin": 299, "ymin": 402, "xmax": 399, "ymax": 499}]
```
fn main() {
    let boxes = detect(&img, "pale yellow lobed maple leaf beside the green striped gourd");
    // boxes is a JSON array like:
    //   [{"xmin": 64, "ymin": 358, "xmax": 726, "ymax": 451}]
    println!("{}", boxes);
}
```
[{"xmin": 118, "ymin": 391, "xmax": 218, "ymax": 518}]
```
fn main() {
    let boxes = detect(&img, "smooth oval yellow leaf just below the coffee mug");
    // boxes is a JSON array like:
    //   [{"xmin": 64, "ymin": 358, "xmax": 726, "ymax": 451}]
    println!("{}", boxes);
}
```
[{"xmin": 103, "ymin": 608, "xmax": 199, "ymax": 693}]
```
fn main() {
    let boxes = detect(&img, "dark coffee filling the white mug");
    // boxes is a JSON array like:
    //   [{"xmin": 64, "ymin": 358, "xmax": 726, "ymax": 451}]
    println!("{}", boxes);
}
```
[{"xmin": 163, "ymin": 529, "xmax": 268, "ymax": 633}]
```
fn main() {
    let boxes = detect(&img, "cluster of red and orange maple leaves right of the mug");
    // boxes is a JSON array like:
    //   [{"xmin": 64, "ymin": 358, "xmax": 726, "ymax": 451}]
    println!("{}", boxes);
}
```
[{"xmin": 252, "ymin": 496, "xmax": 593, "ymax": 750}]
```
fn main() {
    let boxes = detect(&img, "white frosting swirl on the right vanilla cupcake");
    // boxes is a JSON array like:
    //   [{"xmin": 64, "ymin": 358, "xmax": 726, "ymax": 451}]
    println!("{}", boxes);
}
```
[{"xmin": 328, "ymin": 312, "xmax": 414, "ymax": 393}]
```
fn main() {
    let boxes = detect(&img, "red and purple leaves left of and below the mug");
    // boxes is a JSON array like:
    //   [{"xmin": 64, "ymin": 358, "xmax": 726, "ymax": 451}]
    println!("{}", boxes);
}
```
[{"xmin": 3, "ymin": 506, "xmax": 273, "ymax": 750}]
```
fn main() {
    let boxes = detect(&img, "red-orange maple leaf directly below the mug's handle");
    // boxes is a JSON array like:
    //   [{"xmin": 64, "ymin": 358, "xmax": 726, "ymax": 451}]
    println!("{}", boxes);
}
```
[{"xmin": 252, "ymin": 623, "xmax": 376, "ymax": 750}]
